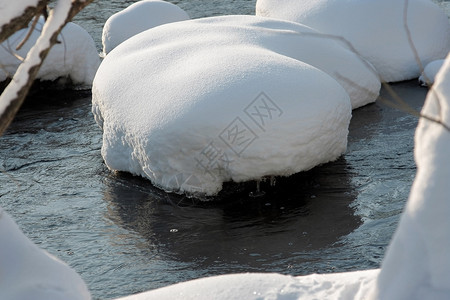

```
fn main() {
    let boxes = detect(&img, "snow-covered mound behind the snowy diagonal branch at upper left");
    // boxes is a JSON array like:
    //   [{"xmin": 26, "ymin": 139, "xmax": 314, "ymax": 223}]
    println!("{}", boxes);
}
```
[{"xmin": 0, "ymin": 18, "xmax": 100, "ymax": 87}]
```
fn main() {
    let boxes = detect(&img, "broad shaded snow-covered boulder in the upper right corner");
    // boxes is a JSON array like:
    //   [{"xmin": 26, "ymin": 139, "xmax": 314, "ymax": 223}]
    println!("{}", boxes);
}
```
[{"xmin": 256, "ymin": 0, "xmax": 450, "ymax": 82}]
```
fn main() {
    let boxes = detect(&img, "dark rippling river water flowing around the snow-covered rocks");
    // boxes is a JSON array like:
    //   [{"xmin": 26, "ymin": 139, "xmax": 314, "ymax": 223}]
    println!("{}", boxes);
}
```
[{"xmin": 0, "ymin": 0, "xmax": 448, "ymax": 299}]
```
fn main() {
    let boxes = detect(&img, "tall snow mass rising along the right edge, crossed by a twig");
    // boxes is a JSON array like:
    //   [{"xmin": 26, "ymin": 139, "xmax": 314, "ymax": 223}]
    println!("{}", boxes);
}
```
[{"xmin": 370, "ymin": 56, "xmax": 450, "ymax": 299}]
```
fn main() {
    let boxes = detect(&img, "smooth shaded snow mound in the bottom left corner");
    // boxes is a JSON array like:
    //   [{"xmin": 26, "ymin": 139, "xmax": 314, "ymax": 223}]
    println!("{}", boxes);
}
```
[{"xmin": 0, "ymin": 207, "xmax": 90, "ymax": 300}]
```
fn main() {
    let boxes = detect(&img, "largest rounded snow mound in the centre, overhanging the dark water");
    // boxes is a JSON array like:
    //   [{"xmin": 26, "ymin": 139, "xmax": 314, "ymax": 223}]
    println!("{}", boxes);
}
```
[{"xmin": 92, "ymin": 16, "xmax": 351, "ymax": 195}]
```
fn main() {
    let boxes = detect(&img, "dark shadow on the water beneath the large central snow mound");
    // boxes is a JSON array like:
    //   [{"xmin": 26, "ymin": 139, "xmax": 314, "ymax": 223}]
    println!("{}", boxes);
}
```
[{"xmin": 104, "ymin": 158, "xmax": 361, "ymax": 273}]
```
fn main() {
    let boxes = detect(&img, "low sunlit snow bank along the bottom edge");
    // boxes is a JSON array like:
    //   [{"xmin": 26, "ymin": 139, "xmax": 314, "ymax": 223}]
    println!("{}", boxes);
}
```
[{"xmin": 117, "ymin": 270, "xmax": 379, "ymax": 300}]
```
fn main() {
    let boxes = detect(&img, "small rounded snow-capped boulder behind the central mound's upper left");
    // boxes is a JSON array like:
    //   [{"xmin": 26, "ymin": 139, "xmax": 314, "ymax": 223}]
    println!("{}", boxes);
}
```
[{"xmin": 102, "ymin": 0, "xmax": 189, "ymax": 55}]
